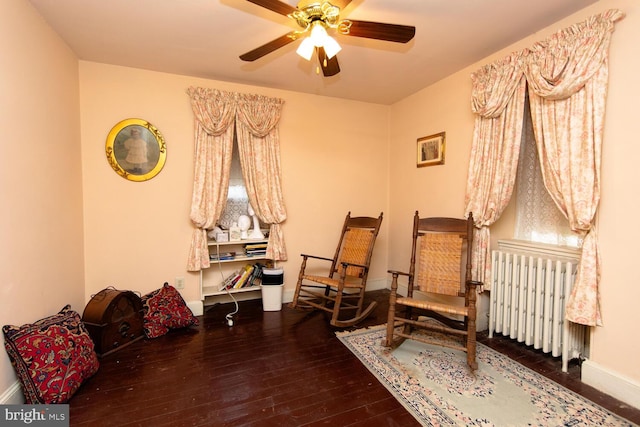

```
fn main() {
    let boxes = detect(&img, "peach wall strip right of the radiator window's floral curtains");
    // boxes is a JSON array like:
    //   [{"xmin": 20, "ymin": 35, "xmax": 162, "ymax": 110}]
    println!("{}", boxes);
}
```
[{"xmin": 590, "ymin": 0, "xmax": 640, "ymax": 407}]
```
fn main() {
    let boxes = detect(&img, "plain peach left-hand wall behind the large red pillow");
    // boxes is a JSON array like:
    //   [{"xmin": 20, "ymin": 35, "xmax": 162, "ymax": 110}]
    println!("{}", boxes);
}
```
[{"xmin": 0, "ymin": 1, "xmax": 84, "ymax": 402}]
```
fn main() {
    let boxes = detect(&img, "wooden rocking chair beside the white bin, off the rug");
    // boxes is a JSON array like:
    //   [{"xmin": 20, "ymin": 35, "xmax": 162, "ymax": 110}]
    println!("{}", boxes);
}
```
[{"xmin": 290, "ymin": 212, "xmax": 382, "ymax": 328}]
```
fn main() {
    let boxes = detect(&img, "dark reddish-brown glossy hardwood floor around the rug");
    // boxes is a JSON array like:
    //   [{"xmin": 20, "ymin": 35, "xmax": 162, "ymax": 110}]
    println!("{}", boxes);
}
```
[{"xmin": 70, "ymin": 291, "xmax": 640, "ymax": 427}]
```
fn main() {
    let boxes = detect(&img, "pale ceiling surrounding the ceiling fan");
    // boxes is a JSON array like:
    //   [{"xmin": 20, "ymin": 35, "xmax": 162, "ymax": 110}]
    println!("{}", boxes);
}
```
[{"xmin": 30, "ymin": 0, "xmax": 597, "ymax": 104}]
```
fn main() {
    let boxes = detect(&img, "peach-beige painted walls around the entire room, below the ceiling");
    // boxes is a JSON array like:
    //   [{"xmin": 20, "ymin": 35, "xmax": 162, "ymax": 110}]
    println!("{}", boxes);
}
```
[{"xmin": 0, "ymin": 0, "xmax": 640, "ymax": 412}]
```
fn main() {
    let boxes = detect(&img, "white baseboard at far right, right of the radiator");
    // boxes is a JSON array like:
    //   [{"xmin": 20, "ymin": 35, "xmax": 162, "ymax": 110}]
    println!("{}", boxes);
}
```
[{"xmin": 581, "ymin": 360, "xmax": 640, "ymax": 408}]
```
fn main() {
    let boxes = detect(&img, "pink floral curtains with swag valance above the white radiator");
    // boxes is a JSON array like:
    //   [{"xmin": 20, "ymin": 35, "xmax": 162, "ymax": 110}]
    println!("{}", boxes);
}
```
[{"xmin": 465, "ymin": 9, "xmax": 624, "ymax": 325}]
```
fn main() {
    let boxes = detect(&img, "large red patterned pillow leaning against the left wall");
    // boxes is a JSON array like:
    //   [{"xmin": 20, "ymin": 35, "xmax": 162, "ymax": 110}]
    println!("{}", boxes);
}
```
[{"xmin": 2, "ymin": 305, "xmax": 99, "ymax": 404}]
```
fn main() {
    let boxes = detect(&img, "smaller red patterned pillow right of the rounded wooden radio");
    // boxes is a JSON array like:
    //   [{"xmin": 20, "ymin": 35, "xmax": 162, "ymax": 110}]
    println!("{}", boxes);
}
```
[{"xmin": 142, "ymin": 283, "xmax": 198, "ymax": 338}]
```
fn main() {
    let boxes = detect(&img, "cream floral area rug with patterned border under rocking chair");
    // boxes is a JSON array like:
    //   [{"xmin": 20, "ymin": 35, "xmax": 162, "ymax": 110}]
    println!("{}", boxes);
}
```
[{"xmin": 337, "ymin": 320, "xmax": 635, "ymax": 427}]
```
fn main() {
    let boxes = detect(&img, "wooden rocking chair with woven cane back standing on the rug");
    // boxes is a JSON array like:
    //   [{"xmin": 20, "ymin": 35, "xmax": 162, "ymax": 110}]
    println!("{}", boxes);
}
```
[{"xmin": 384, "ymin": 211, "xmax": 482, "ymax": 371}]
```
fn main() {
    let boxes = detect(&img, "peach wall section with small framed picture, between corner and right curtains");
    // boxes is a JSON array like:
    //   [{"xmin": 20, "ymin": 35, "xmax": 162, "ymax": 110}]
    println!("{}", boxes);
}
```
[{"xmin": 389, "ymin": 74, "xmax": 473, "ymax": 271}]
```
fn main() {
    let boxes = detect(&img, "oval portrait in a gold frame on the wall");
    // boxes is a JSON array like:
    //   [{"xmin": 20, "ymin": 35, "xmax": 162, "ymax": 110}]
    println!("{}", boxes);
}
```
[{"xmin": 105, "ymin": 119, "xmax": 167, "ymax": 181}]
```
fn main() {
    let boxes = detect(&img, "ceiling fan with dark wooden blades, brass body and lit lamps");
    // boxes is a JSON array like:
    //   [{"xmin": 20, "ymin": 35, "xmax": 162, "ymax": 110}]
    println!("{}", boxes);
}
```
[{"xmin": 240, "ymin": 0, "xmax": 416, "ymax": 77}]
